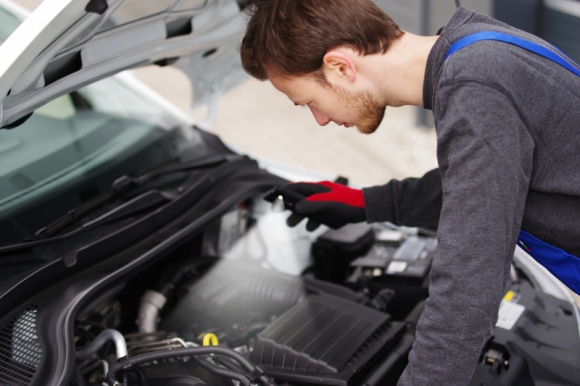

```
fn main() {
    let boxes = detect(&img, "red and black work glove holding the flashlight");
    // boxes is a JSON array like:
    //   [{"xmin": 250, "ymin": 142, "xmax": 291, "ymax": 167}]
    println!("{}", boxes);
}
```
[{"xmin": 284, "ymin": 181, "xmax": 367, "ymax": 231}]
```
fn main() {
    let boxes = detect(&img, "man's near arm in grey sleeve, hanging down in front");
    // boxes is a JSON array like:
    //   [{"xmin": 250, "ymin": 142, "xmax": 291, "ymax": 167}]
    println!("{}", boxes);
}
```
[{"xmin": 399, "ymin": 82, "xmax": 534, "ymax": 386}]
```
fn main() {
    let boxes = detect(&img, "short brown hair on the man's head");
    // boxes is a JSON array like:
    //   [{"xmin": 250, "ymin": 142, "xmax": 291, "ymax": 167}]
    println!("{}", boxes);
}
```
[{"xmin": 240, "ymin": 0, "xmax": 403, "ymax": 80}]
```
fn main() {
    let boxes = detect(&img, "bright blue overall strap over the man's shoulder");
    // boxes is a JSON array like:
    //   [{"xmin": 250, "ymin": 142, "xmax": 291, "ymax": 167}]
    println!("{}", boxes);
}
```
[{"xmin": 445, "ymin": 31, "xmax": 580, "ymax": 76}]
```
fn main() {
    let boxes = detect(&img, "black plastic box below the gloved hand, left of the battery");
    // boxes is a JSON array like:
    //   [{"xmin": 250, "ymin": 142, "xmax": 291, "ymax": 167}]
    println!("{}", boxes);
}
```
[{"xmin": 311, "ymin": 223, "xmax": 375, "ymax": 284}]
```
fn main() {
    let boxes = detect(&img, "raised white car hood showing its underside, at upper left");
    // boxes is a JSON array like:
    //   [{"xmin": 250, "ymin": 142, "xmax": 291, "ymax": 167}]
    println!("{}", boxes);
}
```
[{"xmin": 0, "ymin": 0, "xmax": 248, "ymax": 127}]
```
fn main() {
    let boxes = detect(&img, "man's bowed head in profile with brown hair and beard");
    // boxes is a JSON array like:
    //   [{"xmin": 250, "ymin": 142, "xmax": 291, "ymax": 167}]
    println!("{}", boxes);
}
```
[{"xmin": 241, "ymin": 0, "xmax": 403, "ymax": 134}]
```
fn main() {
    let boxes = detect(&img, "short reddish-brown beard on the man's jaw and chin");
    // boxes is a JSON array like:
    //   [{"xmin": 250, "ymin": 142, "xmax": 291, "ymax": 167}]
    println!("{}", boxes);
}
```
[{"xmin": 333, "ymin": 86, "xmax": 387, "ymax": 134}]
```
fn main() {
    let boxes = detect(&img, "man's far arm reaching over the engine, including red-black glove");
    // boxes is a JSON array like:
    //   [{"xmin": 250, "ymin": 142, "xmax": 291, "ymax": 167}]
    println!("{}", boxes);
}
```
[{"xmin": 274, "ymin": 169, "xmax": 441, "ymax": 230}]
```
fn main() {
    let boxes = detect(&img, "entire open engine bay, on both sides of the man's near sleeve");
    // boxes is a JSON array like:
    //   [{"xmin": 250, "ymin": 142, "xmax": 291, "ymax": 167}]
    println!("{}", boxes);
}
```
[{"xmin": 0, "ymin": 175, "xmax": 580, "ymax": 386}]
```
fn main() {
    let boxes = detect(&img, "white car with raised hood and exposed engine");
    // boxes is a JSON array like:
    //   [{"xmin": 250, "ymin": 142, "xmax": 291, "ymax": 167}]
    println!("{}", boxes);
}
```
[{"xmin": 0, "ymin": 0, "xmax": 580, "ymax": 386}]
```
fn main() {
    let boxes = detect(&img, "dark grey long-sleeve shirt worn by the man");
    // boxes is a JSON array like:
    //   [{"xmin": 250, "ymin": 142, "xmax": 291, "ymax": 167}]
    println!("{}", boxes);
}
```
[{"xmin": 364, "ymin": 8, "xmax": 580, "ymax": 386}]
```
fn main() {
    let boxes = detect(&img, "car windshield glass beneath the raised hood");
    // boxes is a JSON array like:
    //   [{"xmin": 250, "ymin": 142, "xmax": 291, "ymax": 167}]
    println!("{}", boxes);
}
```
[{"xmin": 0, "ymin": 7, "xmax": 202, "ymax": 245}]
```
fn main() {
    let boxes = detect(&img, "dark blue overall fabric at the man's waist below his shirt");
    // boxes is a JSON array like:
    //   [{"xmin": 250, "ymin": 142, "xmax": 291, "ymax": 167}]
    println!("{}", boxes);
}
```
[{"xmin": 518, "ymin": 231, "xmax": 580, "ymax": 295}]
